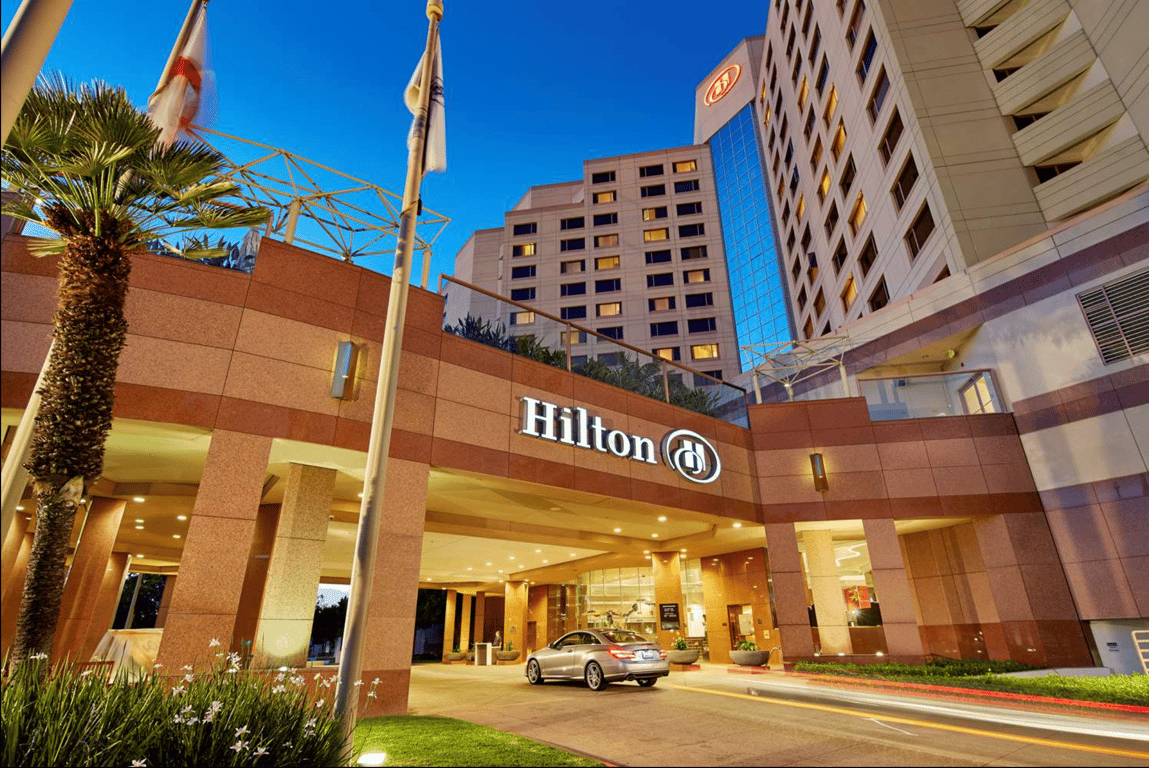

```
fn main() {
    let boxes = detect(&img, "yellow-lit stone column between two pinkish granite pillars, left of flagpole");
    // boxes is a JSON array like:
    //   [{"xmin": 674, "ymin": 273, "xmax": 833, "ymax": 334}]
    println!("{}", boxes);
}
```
[{"xmin": 254, "ymin": 463, "xmax": 336, "ymax": 668}]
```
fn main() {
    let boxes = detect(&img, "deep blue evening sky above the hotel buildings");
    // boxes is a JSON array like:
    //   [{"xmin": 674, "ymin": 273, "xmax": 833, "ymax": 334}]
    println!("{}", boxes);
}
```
[{"xmin": 0, "ymin": 0, "xmax": 769, "ymax": 286}]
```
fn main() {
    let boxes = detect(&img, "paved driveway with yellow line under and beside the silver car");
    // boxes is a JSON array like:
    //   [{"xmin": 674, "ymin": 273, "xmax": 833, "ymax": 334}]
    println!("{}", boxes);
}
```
[{"xmin": 409, "ymin": 665, "xmax": 1149, "ymax": 767}]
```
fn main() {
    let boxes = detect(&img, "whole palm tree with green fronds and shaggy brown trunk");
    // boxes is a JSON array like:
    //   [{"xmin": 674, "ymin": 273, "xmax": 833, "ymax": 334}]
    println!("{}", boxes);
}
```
[{"xmin": 0, "ymin": 76, "xmax": 269, "ymax": 662}]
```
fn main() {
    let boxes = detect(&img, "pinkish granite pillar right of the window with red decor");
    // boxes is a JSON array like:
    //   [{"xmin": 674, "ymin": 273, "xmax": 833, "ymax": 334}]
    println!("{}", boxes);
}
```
[{"xmin": 862, "ymin": 520, "xmax": 925, "ymax": 656}]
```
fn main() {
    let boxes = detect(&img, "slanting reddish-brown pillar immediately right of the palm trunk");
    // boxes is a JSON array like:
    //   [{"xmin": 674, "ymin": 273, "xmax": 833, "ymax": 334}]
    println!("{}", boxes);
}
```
[{"xmin": 52, "ymin": 498, "xmax": 128, "ymax": 662}]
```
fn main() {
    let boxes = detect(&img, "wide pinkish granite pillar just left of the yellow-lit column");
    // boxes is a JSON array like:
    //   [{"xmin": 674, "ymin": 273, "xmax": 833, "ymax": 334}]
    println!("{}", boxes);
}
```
[{"xmin": 159, "ymin": 430, "xmax": 271, "ymax": 670}]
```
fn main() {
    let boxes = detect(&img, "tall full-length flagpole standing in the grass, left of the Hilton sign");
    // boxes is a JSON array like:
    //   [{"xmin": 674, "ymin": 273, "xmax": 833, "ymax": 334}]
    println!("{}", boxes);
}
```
[{"xmin": 336, "ymin": 0, "xmax": 442, "ymax": 738}]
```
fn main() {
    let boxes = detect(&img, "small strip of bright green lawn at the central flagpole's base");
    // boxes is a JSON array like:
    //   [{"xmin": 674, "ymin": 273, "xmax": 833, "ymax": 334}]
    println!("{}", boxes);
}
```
[{"xmin": 355, "ymin": 715, "xmax": 602, "ymax": 767}]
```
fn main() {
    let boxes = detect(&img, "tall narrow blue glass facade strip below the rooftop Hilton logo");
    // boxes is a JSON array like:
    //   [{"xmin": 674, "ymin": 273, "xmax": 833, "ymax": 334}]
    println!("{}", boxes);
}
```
[{"xmin": 709, "ymin": 102, "xmax": 795, "ymax": 370}]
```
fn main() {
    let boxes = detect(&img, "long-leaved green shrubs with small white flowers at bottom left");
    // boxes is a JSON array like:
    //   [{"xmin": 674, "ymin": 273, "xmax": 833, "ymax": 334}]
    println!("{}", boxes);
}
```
[{"xmin": 0, "ymin": 654, "xmax": 353, "ymax": 768}]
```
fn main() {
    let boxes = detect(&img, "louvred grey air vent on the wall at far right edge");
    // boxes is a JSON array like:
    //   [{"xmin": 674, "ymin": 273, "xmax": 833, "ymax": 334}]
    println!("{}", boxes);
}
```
[{"xmin": 1078, "ymin": 269, "xmax": 1149, "ymax": 364}]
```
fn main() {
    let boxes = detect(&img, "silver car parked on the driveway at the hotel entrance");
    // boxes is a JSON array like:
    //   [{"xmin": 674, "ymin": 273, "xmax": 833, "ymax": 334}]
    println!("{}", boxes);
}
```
[{"xmin": 526, "ymin": 629, "xmax": 670, "ymax": 691}]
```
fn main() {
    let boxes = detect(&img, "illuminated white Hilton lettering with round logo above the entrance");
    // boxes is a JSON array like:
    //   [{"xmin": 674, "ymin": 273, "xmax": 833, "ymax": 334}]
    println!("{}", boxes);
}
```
[{"xmin": 518, "ymin": 397, "xmax": 722, "ymax": 484}]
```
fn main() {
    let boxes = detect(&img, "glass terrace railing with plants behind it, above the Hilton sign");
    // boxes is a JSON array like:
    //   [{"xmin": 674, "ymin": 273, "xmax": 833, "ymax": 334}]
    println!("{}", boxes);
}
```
[{"xmin": 439, "ymin": 275, "xmax": 749, "ymax": 427}]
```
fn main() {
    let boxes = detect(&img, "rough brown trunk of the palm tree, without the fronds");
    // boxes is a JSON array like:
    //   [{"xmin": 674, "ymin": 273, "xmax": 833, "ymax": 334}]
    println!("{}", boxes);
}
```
[{"xmin": 10, "ymin": 217, "xmax": 131, "ymax": 663}]
